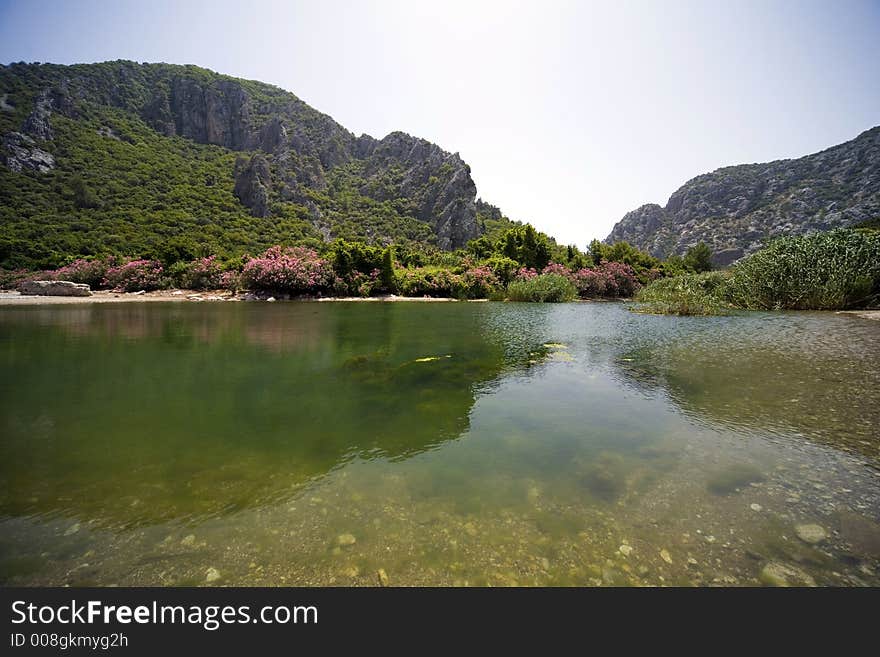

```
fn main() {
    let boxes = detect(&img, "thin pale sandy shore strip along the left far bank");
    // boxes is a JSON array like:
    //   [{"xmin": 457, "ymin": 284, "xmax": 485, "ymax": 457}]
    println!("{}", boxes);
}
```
[{"xmin": 0, "ymin": 290, "xmax": 464, "ymax": 306}]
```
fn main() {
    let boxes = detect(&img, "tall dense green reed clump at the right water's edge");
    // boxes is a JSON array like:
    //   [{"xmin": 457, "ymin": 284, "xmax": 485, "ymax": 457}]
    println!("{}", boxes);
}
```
[{"xmin": 725, "ymin": 229, "xmax": 880, "ymax": 310}]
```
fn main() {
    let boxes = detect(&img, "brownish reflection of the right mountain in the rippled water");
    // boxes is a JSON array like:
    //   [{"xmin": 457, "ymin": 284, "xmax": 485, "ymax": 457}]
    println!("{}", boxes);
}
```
[{"xmin": 614, "ymin": 313, "xmax": 880, "ymax": 459}]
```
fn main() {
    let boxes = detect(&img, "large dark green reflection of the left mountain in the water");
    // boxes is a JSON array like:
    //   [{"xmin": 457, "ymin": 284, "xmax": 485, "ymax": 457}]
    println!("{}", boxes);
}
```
[{"xmin": 0, "ymin": 304, "xmax": 505, "ymax": 525}]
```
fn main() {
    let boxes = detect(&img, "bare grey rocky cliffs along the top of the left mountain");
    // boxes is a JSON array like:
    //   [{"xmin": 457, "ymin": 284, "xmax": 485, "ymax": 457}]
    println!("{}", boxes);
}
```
[{"xmin": 0, "ymin": 62, "xmax": 480, "ymax": 249}]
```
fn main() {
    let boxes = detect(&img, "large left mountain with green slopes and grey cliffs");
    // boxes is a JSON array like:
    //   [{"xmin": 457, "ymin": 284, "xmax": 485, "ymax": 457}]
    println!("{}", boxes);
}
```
[{"xmin": 0, "ymin": 61, "xmax": 502, "ymax": 267}]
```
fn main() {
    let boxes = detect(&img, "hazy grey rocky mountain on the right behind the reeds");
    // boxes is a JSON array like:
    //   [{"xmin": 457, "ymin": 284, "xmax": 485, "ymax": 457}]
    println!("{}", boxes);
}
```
[{"xmin": 605, "ymin": 126, "xmax": 880, "ymax": 265}]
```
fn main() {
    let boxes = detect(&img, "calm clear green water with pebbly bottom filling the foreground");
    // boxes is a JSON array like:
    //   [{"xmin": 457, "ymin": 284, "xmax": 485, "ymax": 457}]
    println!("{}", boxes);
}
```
[{"xmin": 0, "ymin": 303, "xmax": 880, "ymax": 586}]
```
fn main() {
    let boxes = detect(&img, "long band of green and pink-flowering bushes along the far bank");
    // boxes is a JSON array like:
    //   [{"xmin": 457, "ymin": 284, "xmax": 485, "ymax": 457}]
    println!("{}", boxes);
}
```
[{"xmin": 0, "ymin": 219, "xmax": 692, "ymax": 301}]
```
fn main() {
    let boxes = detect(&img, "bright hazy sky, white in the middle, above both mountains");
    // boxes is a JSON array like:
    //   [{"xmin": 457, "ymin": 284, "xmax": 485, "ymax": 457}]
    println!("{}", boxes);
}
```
[{"xmin": 0, "ymin": 0, "xmax": 880, "ymax": 246}]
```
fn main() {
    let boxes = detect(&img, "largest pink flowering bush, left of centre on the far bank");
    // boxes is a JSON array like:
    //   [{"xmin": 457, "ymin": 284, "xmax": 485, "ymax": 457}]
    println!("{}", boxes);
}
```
[{"xmin": 241, "ymin": 246, "xmax": 336, "ymax": 294}]
